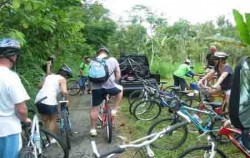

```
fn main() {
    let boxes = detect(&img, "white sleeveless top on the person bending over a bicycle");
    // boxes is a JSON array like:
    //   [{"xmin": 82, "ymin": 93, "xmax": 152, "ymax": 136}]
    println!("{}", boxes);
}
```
[{"xmin": 35, "ymin": 74, "xmax": 64, "ymax": 106}]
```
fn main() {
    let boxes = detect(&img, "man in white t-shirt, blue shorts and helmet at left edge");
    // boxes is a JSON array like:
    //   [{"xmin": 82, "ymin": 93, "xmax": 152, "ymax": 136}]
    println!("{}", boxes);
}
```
[{"xmin": 0, "ymin": 38, "xmax": 31, "ymax": 158}]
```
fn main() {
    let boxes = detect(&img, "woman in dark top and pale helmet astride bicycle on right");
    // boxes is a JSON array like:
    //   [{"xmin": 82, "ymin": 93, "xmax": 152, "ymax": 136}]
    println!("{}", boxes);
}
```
[{"xmin": 198, "ymin": 52, "xmax": 233, "ymax": 110}]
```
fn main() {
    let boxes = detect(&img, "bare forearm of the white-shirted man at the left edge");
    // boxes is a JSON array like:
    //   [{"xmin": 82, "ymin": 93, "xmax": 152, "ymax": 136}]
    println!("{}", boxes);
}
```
[{"xmin": 15, "ymin": 102, "xmax": 31, "ymax": 123}]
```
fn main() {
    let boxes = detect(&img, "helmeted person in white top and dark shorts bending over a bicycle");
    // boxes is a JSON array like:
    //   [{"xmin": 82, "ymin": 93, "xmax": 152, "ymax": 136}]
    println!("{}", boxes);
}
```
[{"xmin": 35, "ymin": 65, "xmax": 72, "ymax": 133}]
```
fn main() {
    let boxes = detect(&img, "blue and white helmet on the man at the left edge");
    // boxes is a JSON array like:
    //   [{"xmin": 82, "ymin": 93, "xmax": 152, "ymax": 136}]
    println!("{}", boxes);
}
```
[{"xmin": 0, "ymin": 38, "xmax": 21, "ymax": 57}]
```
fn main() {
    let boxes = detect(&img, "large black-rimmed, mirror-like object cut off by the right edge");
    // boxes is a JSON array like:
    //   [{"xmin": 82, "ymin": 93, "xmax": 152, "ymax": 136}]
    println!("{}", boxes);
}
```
[{"xmin": 229, "ymin": 57, "xmax": 250, "ymax": 149}]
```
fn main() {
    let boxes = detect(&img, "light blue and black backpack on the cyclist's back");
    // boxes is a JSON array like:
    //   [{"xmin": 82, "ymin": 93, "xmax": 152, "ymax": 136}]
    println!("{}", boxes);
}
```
[{"xmin": 89, "ymin": 58, "xmax": 112, "ymax": 83}]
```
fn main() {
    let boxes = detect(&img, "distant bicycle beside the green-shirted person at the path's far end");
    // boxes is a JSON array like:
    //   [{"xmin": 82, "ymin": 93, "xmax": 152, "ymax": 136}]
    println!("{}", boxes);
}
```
[{"xmin": 67, "ymin": 75, "xmax": 88, "ymax": 96}]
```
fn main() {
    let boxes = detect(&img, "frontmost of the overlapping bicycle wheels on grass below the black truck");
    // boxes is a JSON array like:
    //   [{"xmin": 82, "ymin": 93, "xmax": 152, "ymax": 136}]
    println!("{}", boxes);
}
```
[{"xmin": 133, "ymin": 100, "xmax": 161, "ymax": 121}]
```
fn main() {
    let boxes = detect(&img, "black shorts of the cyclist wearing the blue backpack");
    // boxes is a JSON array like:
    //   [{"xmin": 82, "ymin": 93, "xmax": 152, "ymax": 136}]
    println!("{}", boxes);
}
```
[{"xmin": 92, "ymin": 87, "xmax": 121, "ymax": 106}]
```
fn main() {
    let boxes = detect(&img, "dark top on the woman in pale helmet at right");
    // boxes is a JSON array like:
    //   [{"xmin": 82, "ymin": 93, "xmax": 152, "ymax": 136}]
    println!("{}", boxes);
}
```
[{"xmin": 214, "ymin": 64, "xmax": 233, "ymax": 90}]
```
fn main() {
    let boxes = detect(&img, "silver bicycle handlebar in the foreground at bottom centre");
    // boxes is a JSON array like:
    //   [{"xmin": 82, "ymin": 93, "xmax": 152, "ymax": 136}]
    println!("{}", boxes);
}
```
[{"xmin": 91, "ymin": 117, "xmax": 190, "ymax": 158}]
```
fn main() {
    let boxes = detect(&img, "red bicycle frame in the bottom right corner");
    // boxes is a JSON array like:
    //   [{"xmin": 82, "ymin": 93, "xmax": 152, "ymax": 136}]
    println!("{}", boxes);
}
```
[{"xmin": 218, "ymin": 127, "xmax": 250, "ymax": 158}]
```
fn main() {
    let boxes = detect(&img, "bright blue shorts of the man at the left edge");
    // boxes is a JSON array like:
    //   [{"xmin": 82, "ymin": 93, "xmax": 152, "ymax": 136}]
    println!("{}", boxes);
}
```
[{"xmin": 0, "ymin": 134, "xmax": 21, "ymax": 158}]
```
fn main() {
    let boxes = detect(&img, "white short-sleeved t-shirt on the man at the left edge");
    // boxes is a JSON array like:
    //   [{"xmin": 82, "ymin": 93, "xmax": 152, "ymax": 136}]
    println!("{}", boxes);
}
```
[{"xmin": 0, "ymin": 66, "xmax": 30, "ymax": 137}]
